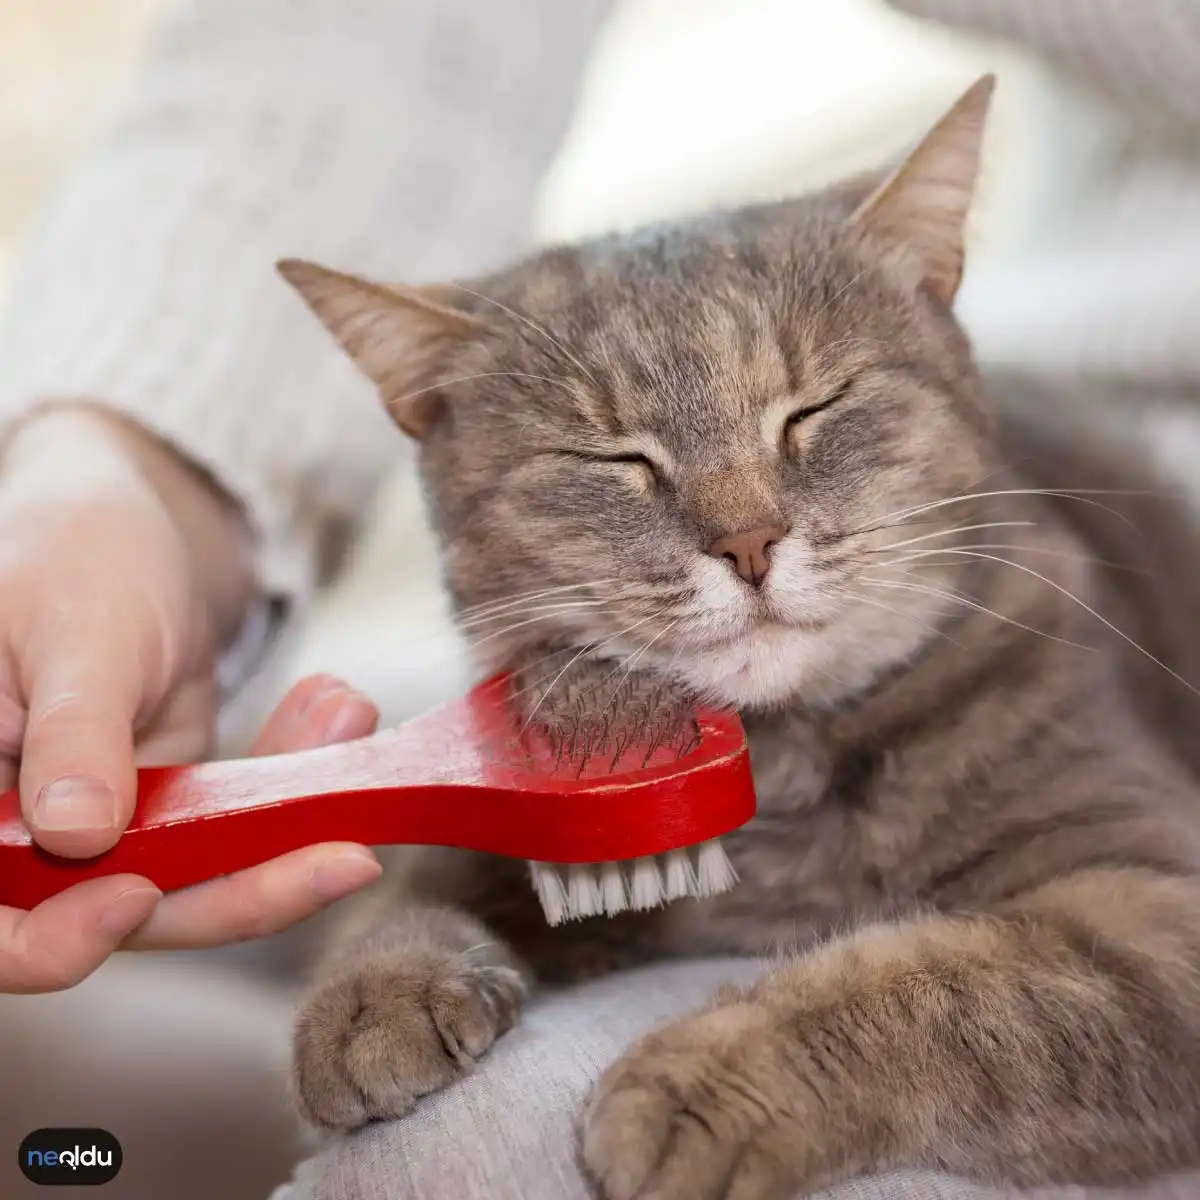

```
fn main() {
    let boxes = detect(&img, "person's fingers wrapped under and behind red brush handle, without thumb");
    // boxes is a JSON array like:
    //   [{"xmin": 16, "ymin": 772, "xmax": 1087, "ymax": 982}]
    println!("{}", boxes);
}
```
[{"xmin": 0, "ymin": 676, "xmax": 380, "ymax": 994}]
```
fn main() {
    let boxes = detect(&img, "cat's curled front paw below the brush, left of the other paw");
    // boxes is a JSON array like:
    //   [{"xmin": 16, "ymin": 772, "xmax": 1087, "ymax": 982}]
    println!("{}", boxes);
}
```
[{"xmin": 293, "ymin": 952, "xmax": 526, "ymax": 1129}]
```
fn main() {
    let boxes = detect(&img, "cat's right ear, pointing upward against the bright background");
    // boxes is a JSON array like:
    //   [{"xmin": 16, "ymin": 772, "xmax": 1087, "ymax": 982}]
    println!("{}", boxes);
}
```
[{"xmin": 850, "ymin": 74, "xmax": 996, "ymax": 304}]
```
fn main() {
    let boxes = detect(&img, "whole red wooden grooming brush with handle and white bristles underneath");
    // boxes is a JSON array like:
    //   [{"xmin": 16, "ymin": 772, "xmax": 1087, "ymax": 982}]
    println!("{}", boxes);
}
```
[{"xmin": 0, "ymin": 679, "xmax": 755, "ymax": 924}]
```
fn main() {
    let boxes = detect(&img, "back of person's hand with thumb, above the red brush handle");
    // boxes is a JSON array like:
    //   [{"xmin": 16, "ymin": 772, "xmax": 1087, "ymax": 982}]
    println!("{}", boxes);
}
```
[{"xmin": 0, "ymin": 409, "xmax": 260, "ymax": 858}]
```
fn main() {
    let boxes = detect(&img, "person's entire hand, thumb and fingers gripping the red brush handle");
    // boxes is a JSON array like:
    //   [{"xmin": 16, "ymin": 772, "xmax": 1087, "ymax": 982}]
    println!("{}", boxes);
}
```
[{"xmin": 0, "ymin": 408, "xmax": 378, "ymax": 991}]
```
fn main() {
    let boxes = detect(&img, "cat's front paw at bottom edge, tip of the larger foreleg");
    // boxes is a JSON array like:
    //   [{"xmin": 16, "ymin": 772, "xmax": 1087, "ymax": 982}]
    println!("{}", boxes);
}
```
[{"xmin": 583, "ymin": 1002, "xmax": 796, "ymax": 1200}]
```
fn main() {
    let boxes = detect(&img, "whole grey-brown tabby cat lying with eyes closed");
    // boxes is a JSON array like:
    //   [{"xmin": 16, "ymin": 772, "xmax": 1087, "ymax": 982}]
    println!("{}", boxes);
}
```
[{"xmin": 280, "ymin": 77, "xmax": 1200, "ymax": 1200}]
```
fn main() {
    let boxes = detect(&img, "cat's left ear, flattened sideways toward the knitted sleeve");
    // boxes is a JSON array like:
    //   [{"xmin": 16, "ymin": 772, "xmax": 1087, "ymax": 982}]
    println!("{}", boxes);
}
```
[{"xmin": 275, "ymin": 258, "xmax": 484, "ymax": 438}]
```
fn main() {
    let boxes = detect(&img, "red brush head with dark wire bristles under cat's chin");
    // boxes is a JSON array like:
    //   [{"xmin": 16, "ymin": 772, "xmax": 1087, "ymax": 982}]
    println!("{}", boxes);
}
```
[{"xmin": 443, "ymin": 667, "xmax": 755, "ymax": 865}]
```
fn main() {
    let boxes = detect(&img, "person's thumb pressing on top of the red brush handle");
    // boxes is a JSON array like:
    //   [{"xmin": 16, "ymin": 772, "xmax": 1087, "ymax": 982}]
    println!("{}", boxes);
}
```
[{"xmin": 19, "ymin": 625, "xmax": 142, "ymax": 858}]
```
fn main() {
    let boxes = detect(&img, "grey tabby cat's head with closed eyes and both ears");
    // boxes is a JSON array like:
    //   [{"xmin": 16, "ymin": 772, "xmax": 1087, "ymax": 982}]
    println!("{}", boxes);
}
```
[{"xmin": 281, "ymin": 78, "xmax": 995, "ymax": 707}]
